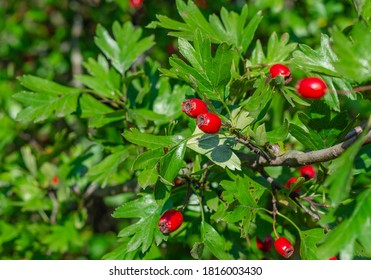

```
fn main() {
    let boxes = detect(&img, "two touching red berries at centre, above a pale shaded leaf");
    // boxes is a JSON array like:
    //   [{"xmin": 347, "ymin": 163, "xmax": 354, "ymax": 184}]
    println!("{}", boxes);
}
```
[{"xmin": 182, "ymin": 98, "xmax": 222, "ymax": 134}]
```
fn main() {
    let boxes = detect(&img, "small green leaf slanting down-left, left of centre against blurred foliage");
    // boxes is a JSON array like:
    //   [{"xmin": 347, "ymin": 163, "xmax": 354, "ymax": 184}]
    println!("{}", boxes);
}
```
[{"xmin": 86, "ymin": 149, "xmax": 129, "ymax": 187}]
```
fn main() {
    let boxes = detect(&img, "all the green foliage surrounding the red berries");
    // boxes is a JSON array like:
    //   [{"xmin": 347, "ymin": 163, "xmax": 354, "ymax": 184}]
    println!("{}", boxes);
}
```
[{"xmin": 0, "ymin": 0, "xmax": 371, "ymax": 260}]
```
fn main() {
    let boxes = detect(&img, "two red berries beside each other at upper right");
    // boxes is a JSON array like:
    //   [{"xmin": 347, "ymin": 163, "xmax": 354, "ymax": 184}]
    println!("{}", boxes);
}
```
[{"xmin": 269, "ymin": 64, "xmax": 327, "ymax": 99}]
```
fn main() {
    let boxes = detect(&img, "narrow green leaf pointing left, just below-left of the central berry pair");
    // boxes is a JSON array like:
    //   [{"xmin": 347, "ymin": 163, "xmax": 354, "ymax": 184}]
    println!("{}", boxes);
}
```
[{"xmin": 122, "ymin": 128, "xmax": 182, "ymax": 149}]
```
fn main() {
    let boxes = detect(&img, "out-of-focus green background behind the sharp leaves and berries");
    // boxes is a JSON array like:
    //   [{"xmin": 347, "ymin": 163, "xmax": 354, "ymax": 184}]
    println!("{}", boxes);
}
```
[{"xmin": 0, "ymin": 0, "xmax": 357, "ymax": 259}]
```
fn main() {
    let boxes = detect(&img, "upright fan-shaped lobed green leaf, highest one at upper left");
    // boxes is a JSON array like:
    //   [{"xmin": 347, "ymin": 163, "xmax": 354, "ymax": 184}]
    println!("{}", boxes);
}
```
[{"xmin": 94, "ymin": 21, "xmax": 154, "ymax": 75}]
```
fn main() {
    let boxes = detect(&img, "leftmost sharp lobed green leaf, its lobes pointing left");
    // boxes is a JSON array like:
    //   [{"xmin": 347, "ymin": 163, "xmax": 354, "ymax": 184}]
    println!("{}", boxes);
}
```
[{"xmin": 13, "ymin": 75, "xmax": 80, "ymax": 122}]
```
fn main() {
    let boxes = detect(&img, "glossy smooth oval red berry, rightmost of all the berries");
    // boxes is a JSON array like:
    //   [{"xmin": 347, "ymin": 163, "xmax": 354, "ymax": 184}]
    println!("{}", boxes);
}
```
[{"xmin": 296, "ymin": 77, "xmax": 327, "ymax": 99}]
